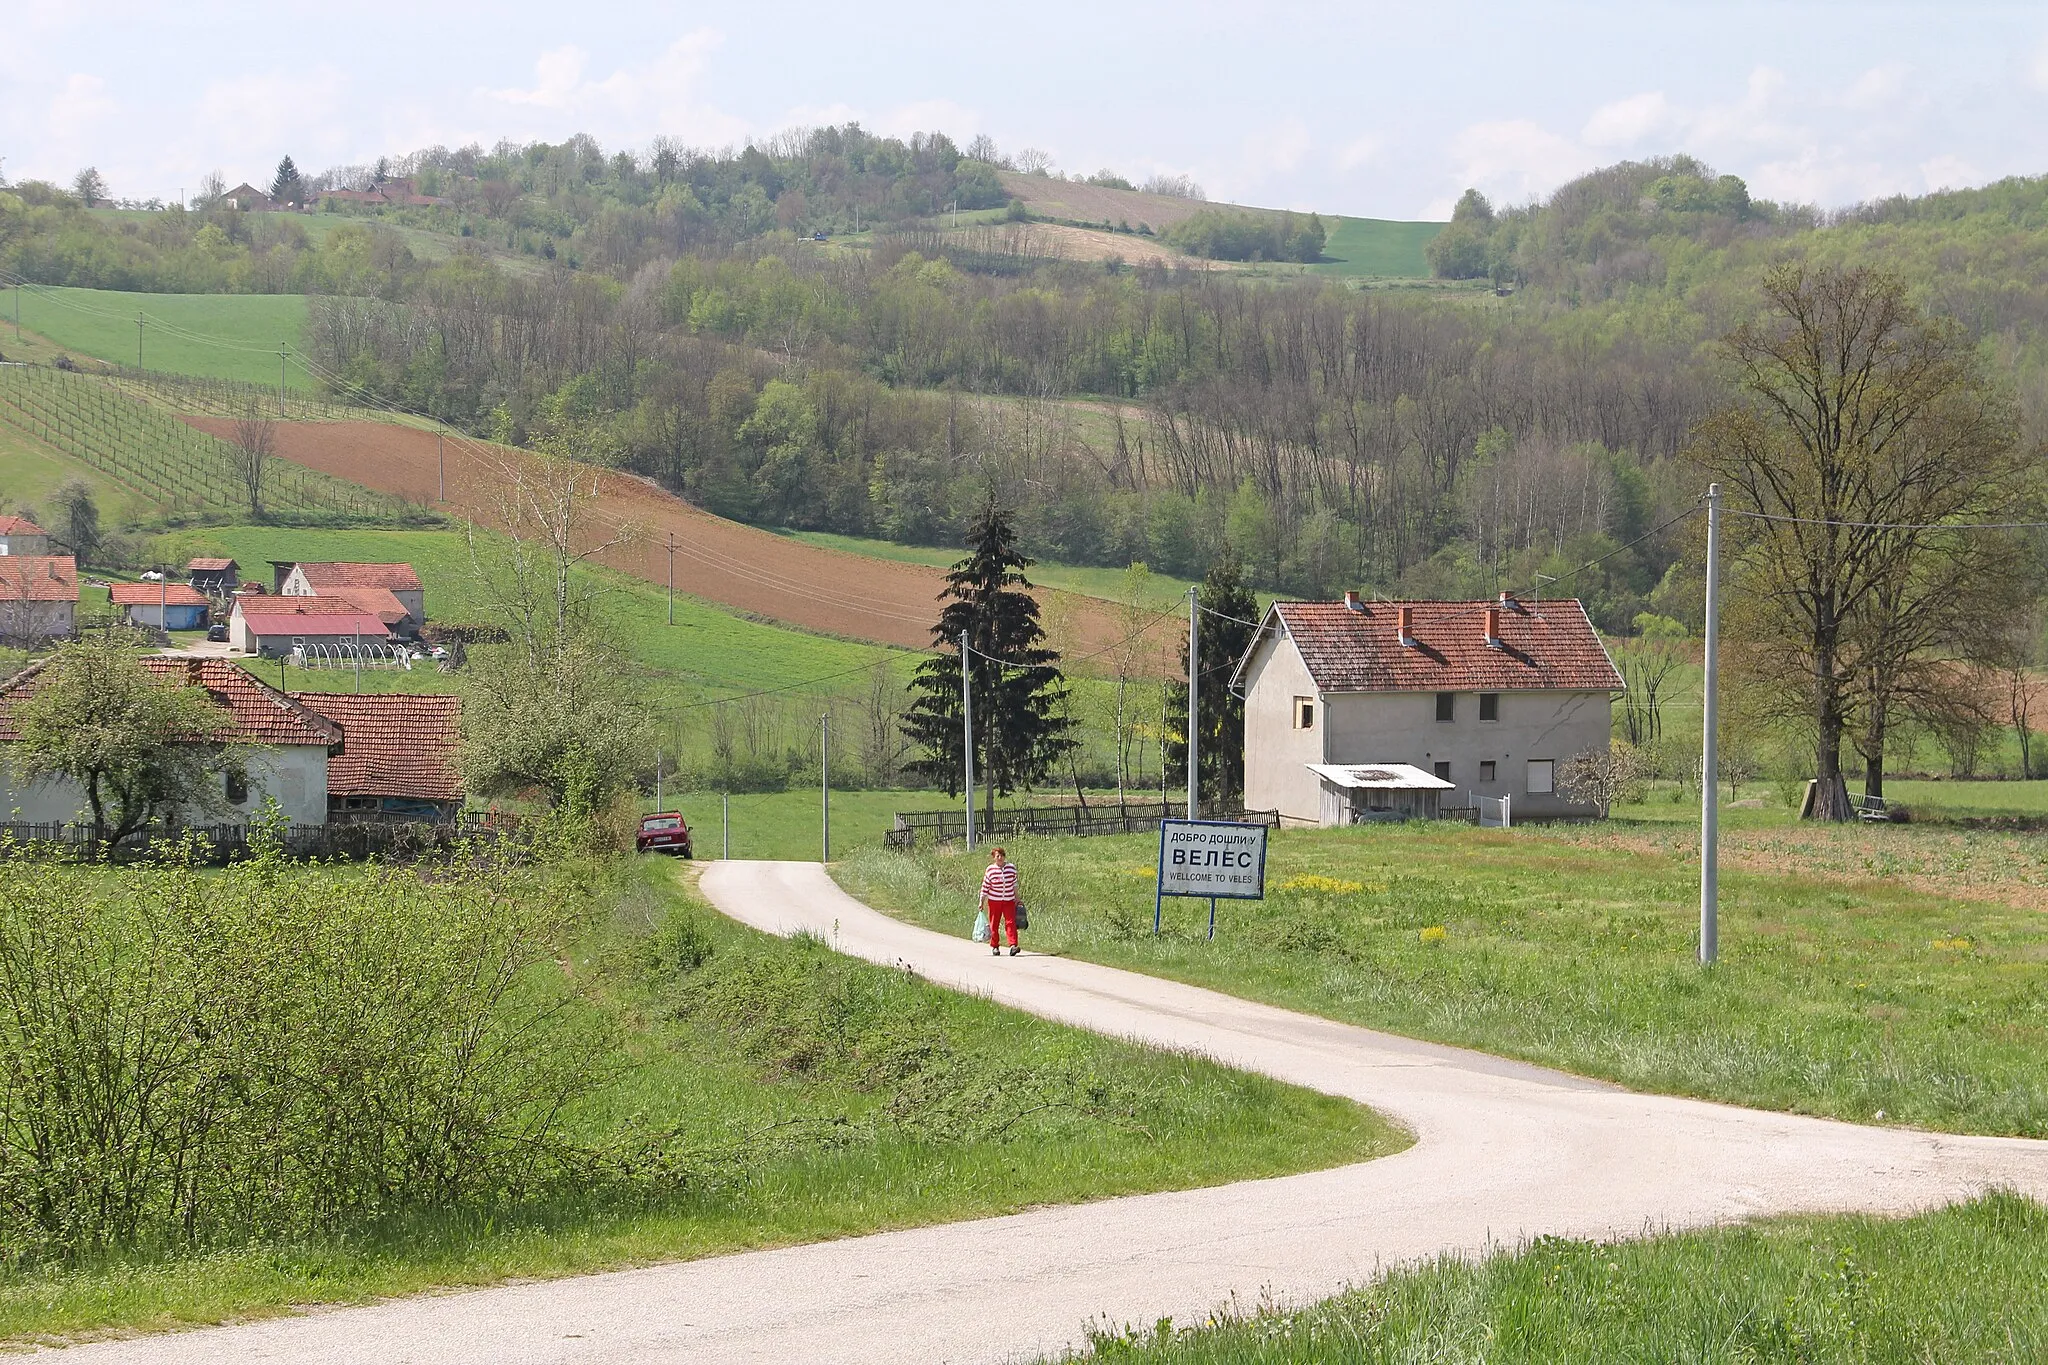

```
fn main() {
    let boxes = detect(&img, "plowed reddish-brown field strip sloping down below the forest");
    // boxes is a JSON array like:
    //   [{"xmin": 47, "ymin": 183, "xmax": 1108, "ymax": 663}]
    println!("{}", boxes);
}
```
[{"xmin": 184, "ymin": 417, "xmax": 1171, "ymax": 655}]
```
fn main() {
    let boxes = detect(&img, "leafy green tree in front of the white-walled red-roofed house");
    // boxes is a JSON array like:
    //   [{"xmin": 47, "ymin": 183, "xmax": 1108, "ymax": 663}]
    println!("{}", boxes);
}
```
[{"xmin": 6, "ymin": 628, "xmax": 246, "ymax": 843}]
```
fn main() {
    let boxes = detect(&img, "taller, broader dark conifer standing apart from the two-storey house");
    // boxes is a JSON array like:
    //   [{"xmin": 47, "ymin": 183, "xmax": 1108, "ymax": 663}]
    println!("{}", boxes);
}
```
[{"xmin": 903, "ymin": 495, "xmax": 1075, "ymax": 810}]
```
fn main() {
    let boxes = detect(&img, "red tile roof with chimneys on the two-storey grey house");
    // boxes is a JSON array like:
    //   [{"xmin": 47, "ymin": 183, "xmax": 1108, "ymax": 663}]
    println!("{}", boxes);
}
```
[{"xmin": 1247, "ymin": 600, "xmax": 1622, "ymax": 692}]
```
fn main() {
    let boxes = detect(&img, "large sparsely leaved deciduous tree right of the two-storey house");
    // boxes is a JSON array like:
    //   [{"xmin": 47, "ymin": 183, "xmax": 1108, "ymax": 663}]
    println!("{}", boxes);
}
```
[{"xmin": 1692, "ymin": 264, "xmax": 2028, "ymax": 821}]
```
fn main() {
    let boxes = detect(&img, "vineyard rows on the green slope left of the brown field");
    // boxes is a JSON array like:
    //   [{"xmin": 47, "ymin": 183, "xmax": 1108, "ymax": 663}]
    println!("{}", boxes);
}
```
[{"xmin": 0, "ymin": 364, "xmax": 401, "ymax": 520}]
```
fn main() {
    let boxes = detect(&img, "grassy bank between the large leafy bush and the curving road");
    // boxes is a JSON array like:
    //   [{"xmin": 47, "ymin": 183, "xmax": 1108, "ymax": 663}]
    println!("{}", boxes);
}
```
[{"xmin": 0, "ymin": 860, "xmax": 1407, "ymax": 1342}]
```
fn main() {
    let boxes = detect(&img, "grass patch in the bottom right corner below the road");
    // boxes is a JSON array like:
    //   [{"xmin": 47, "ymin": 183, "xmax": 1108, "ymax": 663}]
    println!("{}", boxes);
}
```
[{"xmin": 1056, "ymin": 1193, "xmax": 2048, "ymax": 1365}]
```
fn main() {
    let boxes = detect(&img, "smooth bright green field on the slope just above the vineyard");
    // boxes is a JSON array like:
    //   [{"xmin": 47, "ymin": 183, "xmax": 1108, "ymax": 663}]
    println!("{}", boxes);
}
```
[{"xmin": 4, "ymin": 289, "xmax": 313, "ymax": 389}]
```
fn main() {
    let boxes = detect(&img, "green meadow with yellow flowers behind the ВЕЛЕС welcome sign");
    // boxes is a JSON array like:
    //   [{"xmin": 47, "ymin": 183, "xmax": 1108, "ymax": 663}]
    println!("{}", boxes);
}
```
[{"xmin": 834, "ymin": 825, "xmax": 2048, "ymax": 1136}]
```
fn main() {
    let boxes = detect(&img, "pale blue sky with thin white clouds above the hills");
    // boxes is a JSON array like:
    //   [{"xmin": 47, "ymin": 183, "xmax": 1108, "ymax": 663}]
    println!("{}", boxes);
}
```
[{"xmin": 0, "ymin": 0, "xmax": 2048, "ymax": 219}]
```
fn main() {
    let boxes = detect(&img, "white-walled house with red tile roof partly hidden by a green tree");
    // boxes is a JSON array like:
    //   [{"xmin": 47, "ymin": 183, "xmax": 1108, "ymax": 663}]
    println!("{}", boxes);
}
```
[{"xmin": 0, "ymin": 655, "xmax": 342, "ymax": 825}]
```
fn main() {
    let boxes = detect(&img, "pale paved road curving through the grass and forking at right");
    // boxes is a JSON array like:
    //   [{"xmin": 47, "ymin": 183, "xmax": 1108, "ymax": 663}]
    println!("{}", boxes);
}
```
[{"xmin": 44, "ymin": 862, "xmax": 2048, "ymax": 1365}]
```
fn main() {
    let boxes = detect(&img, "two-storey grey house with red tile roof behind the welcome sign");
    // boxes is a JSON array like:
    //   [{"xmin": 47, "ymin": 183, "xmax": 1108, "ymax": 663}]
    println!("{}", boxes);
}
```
[{"xmin": 1231, "ymin": 593, "xmax": 1622, "ymax": 825}]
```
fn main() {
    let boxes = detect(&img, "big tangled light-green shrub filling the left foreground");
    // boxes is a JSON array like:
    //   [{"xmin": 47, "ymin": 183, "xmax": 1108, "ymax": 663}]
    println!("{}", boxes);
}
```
[{"xmin": 0, "ymin": 845, "xmax": 594, "ymax": 1263}]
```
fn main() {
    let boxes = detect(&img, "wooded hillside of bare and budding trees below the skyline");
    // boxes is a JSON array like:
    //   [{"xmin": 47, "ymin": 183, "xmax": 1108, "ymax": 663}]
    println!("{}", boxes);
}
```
[{"xmin": 0, "ymin": 129, "xmax": 2048, "ymax": 630}]
